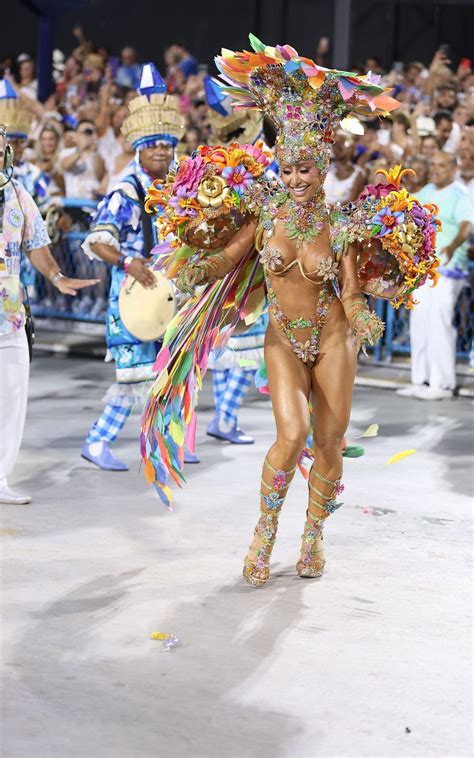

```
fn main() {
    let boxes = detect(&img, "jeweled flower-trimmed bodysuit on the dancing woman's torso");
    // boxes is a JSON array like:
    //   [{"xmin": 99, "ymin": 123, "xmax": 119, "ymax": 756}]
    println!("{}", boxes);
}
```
[{"xmin": 256, "ymin": 199, "xmax": 339, "ymax": 368}]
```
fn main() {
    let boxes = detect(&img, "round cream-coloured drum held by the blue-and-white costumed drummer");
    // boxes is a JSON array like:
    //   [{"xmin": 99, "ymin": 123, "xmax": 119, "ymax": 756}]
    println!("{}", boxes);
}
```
[{"xmin": 119, "ymin": 269, "xmax": 177, "ymax": 342}]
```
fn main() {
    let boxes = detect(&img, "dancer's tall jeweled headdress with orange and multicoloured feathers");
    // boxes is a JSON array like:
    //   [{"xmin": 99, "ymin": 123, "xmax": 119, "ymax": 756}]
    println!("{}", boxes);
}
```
[{"xmin": 215, "ymin": 34, "xmax": 398, "ymax": 172}]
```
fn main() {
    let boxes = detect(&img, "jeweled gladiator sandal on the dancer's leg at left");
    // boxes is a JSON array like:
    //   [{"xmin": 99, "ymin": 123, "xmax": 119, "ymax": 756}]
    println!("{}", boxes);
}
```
[{"xmin": 243, "ymin": 458, "xmax": 295, "ymax": 587}]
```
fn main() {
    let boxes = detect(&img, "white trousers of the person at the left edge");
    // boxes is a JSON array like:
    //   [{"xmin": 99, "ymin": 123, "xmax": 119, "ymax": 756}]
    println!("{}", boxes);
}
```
[{"xmin": 0, "ymin": 329, "xmax": 30, "ymax": 483}]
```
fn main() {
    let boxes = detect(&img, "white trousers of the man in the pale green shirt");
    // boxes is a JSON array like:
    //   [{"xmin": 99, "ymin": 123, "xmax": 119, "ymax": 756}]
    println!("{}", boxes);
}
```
[{"xmin": 410, "ymin": 276, "xmax": 465, "ymax": 390}]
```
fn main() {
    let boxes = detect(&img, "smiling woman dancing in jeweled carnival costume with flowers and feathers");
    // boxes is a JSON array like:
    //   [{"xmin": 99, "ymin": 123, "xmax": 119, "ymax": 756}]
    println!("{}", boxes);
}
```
[{"xmin": 142, "ymin": 36, "xmax": 437, "ymax": 587}]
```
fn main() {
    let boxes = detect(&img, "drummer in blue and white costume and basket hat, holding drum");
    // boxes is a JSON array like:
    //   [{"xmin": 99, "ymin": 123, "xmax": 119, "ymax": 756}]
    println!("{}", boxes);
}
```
[{"xmin": 82, "ymin": 63, "xmax": 188, "ymax": 471}]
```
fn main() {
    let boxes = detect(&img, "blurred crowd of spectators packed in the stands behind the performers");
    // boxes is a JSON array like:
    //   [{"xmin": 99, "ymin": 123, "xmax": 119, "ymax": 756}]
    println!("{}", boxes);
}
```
[{"xmin": 0, "ymin": 27, "xmax": 474, "ymax": 348}]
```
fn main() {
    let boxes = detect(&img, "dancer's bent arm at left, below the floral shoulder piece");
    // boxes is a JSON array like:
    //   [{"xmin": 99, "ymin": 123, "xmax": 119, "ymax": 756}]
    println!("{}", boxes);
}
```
[{"xmin": 176, "ymin": 216, "xmax": 257, "ymax": 292}]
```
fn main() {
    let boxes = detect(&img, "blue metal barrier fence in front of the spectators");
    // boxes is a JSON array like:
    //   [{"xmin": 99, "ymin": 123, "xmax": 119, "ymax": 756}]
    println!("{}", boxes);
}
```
[{"xmin": 31, "ymin": 199, "xmax": 474, "ymax": 361}]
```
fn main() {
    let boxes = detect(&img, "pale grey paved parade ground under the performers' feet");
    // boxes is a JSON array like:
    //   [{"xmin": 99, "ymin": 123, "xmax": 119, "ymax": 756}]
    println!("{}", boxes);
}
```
[{"xmin": 1, "ymin": 354, "xmax": 472, "ymax": 758}]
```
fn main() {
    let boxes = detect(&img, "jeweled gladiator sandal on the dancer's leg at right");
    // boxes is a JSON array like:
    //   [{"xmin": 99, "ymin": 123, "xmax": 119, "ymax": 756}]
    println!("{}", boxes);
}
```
[{"xmin": 296, "ymin": 466, "xmax": 344, "ymax": 579}]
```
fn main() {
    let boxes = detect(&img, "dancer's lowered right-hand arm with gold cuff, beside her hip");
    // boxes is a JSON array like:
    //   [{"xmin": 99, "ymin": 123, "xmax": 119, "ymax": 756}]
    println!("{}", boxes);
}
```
[{"xmin": 339, "ymin": 243, "xmax": 384, "ymax": 345}]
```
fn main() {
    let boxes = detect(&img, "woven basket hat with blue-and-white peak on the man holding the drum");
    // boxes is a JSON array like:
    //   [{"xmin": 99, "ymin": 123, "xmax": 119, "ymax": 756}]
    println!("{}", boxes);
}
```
[{"xmin": 122, "ymin": 63, "xmax": 185, "ymax": 150}]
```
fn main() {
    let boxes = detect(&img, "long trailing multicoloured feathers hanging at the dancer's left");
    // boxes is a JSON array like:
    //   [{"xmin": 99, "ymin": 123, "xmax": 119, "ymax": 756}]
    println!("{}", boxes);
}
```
[{"xmin": 140, "ymin": 250, "xmax": 265, "ymax": 507}]
